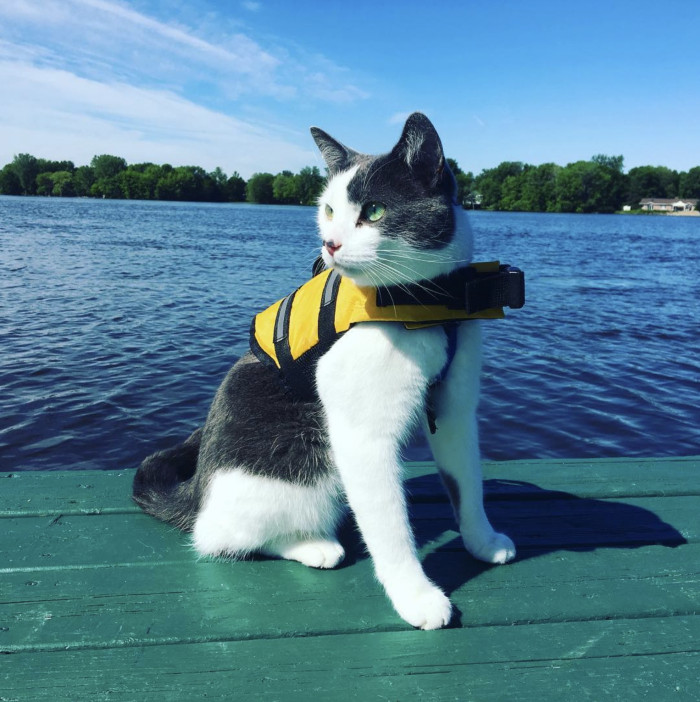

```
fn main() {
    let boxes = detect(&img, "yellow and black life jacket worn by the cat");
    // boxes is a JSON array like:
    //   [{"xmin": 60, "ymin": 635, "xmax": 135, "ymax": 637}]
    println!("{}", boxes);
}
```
[{"xmin": 250, "ymin": 261, "xmax": 525, "ymax": 400}]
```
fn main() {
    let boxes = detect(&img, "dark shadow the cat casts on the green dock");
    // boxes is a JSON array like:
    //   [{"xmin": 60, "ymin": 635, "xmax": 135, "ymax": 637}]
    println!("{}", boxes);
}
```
[{"xmin": 406, "ymin": 474, "xmax": 688, "ymax": 608}]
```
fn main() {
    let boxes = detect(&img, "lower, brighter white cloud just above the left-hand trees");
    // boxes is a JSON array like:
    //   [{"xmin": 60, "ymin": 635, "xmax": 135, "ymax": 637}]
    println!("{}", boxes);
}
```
[{"xmin": 0, "ymin": 61, "xmax": 317, "ymax": 177}]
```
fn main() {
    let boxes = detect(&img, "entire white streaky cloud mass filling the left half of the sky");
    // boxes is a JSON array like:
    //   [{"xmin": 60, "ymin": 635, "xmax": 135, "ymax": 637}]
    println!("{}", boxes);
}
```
[{"xmin": 0, "ymin": 0, "xmax": 368, "ymax": 176}]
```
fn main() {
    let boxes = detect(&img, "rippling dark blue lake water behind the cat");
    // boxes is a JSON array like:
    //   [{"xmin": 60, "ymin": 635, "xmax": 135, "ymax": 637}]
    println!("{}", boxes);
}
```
[{"xmin": 0, "ymin": 197, "xmax": 700, "ymax": 471}]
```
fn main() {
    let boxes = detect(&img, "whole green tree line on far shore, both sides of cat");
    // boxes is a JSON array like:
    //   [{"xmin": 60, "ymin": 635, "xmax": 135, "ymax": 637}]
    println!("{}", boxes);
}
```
[{"xmin": 0, "ymin": 154, "xmax": 700, "ymax": 213}]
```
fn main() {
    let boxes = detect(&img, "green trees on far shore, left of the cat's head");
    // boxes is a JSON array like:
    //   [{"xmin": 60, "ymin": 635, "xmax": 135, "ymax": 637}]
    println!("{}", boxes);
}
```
[{"xmin": 0, "ymin": 154, "xmax": 325, "ymax": 205}]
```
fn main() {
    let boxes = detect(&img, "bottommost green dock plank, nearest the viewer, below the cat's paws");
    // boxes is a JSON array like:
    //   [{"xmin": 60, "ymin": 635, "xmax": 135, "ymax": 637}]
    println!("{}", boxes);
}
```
[{"xmin": 0, "ymin": 616, "xmax": 700, "ymax": 702}]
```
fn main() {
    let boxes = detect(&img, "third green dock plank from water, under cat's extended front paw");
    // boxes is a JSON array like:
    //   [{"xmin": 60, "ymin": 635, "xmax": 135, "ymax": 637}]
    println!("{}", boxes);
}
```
[{"xmin": 0, "ymin": 544, "xmax": 700, "ymax": 652}]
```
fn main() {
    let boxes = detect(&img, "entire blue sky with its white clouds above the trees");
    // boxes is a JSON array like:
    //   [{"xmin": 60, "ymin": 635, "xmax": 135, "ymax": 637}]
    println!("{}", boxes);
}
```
[{"xmin": 0, "ymin": 0, "xmax": 700, "ymax": 178}]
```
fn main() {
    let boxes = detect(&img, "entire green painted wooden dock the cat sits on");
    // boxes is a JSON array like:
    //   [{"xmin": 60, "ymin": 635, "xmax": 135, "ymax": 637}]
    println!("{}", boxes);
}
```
[{"xmin": 0, "ymin": 457, "xmax": 700, "ymax": 702}]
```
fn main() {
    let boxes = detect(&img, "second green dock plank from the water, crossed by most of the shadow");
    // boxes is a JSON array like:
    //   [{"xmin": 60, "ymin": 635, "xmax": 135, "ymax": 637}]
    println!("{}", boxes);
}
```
[{"xmin": 0, "ymin": 497, "xmax": 700, "ymax": 569}]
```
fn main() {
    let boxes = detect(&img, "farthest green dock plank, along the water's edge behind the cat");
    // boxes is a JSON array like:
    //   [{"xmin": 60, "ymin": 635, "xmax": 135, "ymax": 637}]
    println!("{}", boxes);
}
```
[{"xmin": 0, "ymin": 457, "xmax": 700, "ymax": 517}]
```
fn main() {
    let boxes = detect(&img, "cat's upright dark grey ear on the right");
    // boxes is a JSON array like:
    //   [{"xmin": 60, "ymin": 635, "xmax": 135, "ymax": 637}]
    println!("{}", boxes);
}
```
[{"xmin": 391, "ymin": 112, "xmax": 449, "ymax": 189}]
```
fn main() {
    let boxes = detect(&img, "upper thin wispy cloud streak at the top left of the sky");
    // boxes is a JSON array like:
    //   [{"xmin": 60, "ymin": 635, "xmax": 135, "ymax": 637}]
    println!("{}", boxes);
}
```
[{"xmin": 0, "ymin": 0, "xmax": 367, "ymax": 103}]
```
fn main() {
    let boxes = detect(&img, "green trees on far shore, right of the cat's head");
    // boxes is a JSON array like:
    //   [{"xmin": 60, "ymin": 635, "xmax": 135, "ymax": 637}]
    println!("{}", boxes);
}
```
[{"xmin": 448, "ymin": 154, "xmax": 700, "ymax": 213}]
